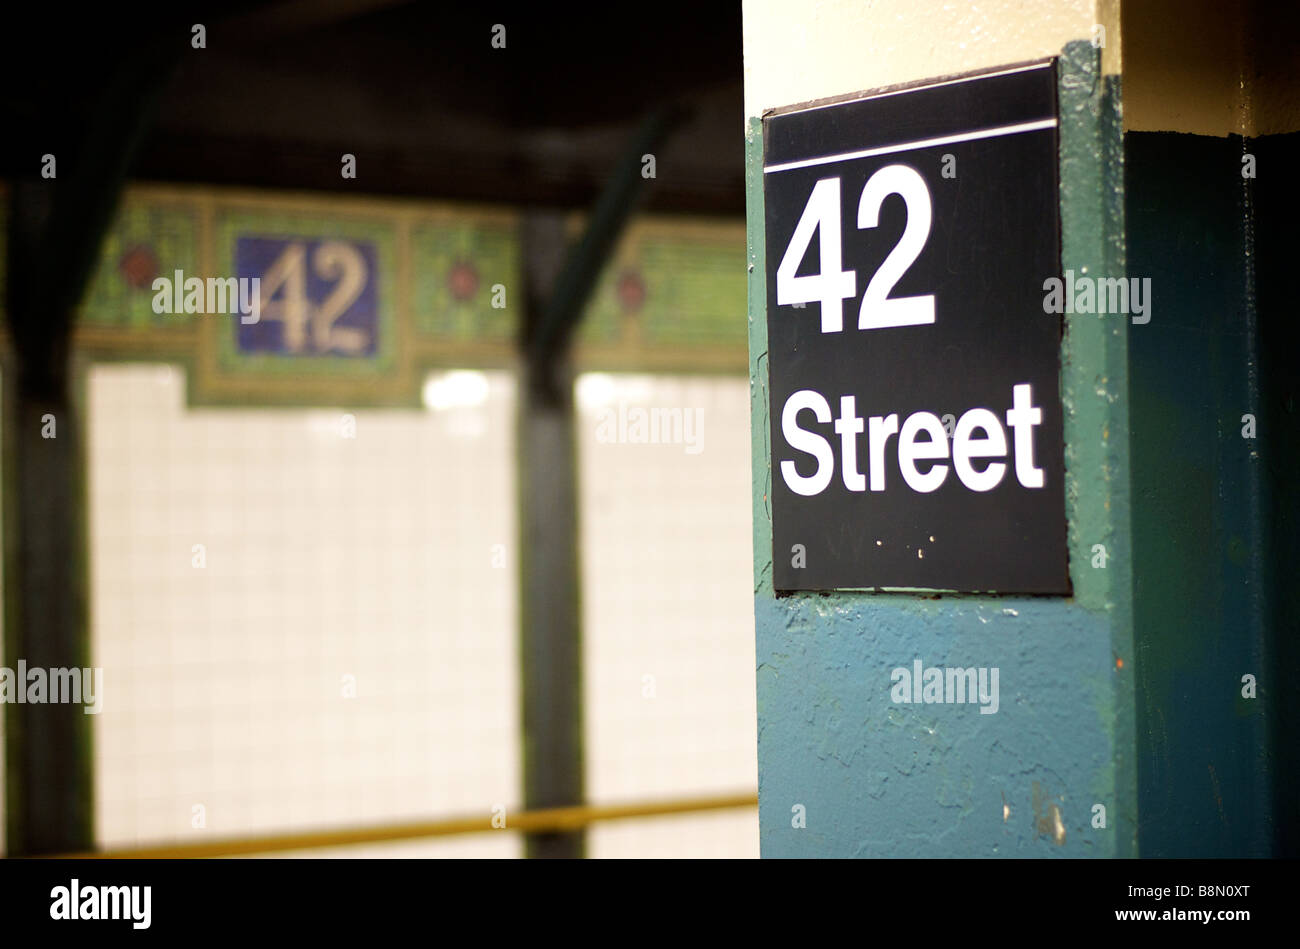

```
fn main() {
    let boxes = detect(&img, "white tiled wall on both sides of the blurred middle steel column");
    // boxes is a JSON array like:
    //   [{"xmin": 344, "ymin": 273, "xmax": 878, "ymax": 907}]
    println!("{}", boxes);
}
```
[{"xmin": 88, "ymin": 365, "xmax": 758, "ymax": 857}]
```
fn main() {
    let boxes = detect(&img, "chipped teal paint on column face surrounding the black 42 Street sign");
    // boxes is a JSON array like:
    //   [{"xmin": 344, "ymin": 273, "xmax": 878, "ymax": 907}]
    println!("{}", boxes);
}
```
[{"xmin": 746, "ymin": 38, "xmax": 1138, "ymax": 857}]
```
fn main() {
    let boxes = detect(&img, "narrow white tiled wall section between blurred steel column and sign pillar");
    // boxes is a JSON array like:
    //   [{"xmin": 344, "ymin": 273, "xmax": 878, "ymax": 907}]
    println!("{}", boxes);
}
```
[{"xmin": 576, "ymin": 374, "xmax": 758, "ymax": 857}]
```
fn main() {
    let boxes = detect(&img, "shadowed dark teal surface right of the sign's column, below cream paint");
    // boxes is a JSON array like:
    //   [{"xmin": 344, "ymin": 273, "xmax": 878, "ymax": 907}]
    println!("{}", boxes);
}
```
[{"xmin": 1125, "ymin": 109, "xmax": 1300, "ymax": 858}]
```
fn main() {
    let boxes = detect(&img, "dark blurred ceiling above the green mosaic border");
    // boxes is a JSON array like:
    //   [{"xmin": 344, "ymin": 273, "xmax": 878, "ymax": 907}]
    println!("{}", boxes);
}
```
[{"xmin": 0, "ymin": 0, "xmax": 744, "ymax": 215}]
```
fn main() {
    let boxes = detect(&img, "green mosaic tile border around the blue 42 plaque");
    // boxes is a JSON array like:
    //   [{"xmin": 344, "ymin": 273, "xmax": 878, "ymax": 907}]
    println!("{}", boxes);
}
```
[{"xmin": 48, "ymin": 185, "xmax": 746, "ymax": 407}]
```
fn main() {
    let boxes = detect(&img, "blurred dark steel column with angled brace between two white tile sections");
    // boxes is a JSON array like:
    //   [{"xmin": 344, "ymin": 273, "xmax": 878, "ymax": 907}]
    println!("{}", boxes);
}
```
[{"xmin": 507, "ymin": 111, "xmax": 679, "ymax": 857}]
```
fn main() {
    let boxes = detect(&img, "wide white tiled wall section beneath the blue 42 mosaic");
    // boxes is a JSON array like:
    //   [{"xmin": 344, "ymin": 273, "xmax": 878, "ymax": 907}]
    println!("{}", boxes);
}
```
[{"xmin": 88, "ymin": 365, "xmax": 520, "ymax": 854}]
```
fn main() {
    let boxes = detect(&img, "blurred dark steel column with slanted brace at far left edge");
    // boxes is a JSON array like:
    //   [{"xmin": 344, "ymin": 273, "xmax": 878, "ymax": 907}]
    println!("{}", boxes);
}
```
[{"xmin": 3, "ymin": 42, "xmax": 174, "ymax": 855}]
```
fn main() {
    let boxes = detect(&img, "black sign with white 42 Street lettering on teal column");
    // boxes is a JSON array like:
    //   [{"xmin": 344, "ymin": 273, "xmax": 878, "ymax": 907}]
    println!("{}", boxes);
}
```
[{"xmin": 763, "ymin": 62, "xmax": 1070, "ymax": 593}]
